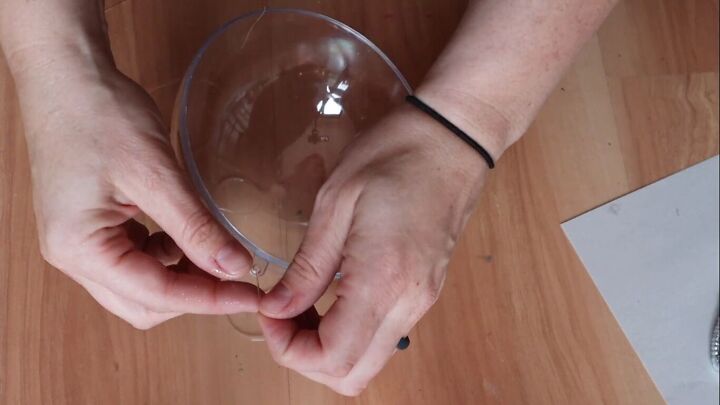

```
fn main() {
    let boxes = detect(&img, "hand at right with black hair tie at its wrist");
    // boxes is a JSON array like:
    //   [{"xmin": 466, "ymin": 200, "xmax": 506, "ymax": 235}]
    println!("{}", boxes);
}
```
[{"xmin": 260, "ymin": 102, "xmax": 487, "ymax": 395}]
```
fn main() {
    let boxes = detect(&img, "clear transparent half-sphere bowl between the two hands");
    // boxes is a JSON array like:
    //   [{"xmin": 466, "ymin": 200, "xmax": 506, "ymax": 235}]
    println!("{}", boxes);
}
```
[{"xmin": 171, "ymin": 8, "xmax": 411, "ymax": 335}]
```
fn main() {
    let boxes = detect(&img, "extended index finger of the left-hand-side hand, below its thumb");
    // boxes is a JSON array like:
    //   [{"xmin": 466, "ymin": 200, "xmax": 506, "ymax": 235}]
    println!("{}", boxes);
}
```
[{"xmin": 87, "ymin": 243, "xmax": 259, "ymax": 314}]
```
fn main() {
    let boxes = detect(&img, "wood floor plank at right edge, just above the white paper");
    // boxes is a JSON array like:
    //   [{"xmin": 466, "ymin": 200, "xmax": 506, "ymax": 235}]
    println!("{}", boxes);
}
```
[{"xmin": 608, "ymin": 72, "xmax": 718, "ymax": 189}]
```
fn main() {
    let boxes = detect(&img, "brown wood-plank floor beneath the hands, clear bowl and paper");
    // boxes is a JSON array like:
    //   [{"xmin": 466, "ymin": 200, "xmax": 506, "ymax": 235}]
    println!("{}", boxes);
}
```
[{"xmin": 0, "ymin": 0, "xmax": 718, "ymax": 405}]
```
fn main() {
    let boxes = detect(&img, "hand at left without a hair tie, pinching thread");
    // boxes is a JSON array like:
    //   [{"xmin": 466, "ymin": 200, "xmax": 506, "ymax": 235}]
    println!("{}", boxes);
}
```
[{"xmin": 13, "ymin": 51, "xmax": 258, "ymax": 329}]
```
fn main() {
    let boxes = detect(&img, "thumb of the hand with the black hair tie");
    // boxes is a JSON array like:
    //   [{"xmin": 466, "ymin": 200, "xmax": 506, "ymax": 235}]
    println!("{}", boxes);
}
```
[{"xmin": 260, "ymin": 185, "xmax": 357, "ymax": 318}]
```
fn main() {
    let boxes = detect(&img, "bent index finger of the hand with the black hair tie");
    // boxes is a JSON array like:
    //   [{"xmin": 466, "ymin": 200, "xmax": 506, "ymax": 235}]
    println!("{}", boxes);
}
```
[{"xmin": 260, "ymin": 234, "xmax": 416, "ymax": 377}]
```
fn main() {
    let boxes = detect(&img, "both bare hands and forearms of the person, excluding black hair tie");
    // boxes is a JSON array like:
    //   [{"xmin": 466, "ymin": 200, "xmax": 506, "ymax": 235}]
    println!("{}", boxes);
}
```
[{"xmin": 0, "ymin": 0, "xmax": 614, "ymax": 395}]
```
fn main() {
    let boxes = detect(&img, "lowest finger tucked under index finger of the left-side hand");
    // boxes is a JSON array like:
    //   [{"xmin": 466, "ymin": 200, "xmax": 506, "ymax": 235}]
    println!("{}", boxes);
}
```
[{"xmin": 78, "ymin": 278, "xmax": 182, "ymax": 330}]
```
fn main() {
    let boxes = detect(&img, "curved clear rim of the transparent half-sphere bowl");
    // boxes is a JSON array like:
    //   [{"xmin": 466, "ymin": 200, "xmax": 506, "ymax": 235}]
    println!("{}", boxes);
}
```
[{"xmin": 179, "ymin": 7, "xmax": 412, "ymax": 270}]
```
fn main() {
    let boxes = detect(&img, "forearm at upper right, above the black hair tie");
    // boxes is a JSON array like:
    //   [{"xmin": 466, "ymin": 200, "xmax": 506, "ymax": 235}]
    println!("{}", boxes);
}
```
[{"xmin": 416, "ymin": 0, "xmax": 617, "ymax": 158}]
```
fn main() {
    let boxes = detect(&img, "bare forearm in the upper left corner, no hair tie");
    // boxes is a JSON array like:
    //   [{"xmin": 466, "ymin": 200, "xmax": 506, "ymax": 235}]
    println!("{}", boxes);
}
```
[{"xmin": 0, "ymin": 0, "xmax": 113, "ymax": 80}]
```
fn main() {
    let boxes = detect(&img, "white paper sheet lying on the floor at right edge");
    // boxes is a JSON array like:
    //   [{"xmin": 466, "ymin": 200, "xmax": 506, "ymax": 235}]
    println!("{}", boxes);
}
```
[{"xmin": 563, "ymin": 156, "xmax": 720, "ymax": 405}]
